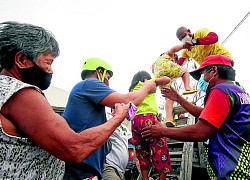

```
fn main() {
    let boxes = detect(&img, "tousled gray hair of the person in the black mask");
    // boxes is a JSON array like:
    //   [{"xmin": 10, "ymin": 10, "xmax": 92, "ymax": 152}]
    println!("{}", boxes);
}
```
[{"xmin": 0, "ymin": 21, "xmax": 60, "ymax": 69}]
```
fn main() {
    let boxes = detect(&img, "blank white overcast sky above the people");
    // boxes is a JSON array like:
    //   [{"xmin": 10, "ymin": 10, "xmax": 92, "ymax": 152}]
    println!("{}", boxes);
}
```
[{"xmin": 0, "ymin": 0, "xmax": 250, "ymax": 93}]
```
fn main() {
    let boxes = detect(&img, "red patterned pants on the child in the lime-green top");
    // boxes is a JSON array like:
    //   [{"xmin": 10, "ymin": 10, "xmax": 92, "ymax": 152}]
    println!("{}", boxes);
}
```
[{"xmin": 131, "ymin": 114, "xmax": 172, "ymax": 173}]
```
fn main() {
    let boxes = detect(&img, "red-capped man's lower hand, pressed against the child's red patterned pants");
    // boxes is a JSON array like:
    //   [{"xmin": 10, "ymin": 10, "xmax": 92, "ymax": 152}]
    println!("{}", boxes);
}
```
[{"xmin": 141, "ymin": 121, "xmax": 166, "ymax": 141}]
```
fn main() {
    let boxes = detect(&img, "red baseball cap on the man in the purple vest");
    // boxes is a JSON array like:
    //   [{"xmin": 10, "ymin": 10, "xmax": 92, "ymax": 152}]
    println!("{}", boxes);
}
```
[{"xmin": 189, "ymin": 54, "xmax": 233, "ymax": 80}]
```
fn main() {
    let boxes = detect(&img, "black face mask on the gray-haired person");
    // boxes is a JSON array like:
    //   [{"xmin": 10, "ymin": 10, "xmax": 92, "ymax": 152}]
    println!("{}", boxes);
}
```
[{"xmin": 19, "ymin": 63, "xmax": 52, "ymax": 90}]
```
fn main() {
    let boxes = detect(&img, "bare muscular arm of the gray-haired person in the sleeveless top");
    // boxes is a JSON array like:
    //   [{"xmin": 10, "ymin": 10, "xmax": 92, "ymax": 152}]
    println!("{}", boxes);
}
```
[{"xmin": 0, "ymin": 88, "xmax": 129, "ymax": 162}]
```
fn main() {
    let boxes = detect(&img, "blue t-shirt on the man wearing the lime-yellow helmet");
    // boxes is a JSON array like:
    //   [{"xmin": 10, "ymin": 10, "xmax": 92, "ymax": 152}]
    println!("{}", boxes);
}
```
[{"xmin": 63, "ymin": 78, "xmax": 115, "ymax": 179}]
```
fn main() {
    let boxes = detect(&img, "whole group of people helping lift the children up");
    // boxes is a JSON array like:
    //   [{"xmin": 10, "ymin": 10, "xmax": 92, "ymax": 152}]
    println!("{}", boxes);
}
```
[{"xmin": 0, "ymin": 22, "xmax": 250, "ymax": 180}]
